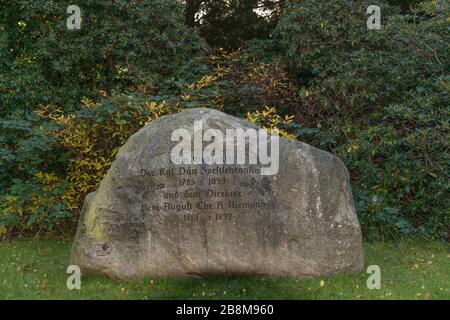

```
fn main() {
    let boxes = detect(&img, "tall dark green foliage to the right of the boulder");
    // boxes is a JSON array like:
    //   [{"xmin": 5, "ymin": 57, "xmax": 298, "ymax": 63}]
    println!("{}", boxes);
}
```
[{"xmin": 262, "ymin": 0, "xmax": 450, "ymax": 238}]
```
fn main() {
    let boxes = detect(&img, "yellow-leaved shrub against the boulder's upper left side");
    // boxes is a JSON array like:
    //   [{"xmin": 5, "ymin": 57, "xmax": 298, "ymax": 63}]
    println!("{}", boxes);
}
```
[{"xmin": 40, "ymin": 94, "xmax": 177, "ymax": 212}]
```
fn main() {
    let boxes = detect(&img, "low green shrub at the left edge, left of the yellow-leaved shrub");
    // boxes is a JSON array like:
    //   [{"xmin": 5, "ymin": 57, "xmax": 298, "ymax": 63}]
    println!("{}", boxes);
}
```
[{"xmin": 0, "ymin": 111, "xmax": 70, "ymax": 235}]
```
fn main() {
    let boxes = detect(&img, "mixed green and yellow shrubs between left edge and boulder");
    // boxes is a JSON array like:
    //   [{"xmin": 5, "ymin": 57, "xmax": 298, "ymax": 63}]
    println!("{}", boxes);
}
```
[{"xmin": 0, "ymin": 94, "xmax": 177, "ymax": 235}]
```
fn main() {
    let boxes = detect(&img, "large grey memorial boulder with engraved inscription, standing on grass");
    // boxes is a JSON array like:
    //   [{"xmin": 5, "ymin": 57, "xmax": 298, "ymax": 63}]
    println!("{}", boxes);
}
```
[{"xmin": 70, "ymin": 109, "xmax": 363, "ymax": 279}]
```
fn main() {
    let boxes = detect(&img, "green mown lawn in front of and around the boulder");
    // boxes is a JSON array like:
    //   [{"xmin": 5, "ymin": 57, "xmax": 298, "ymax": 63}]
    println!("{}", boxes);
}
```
[{"xmin": 0, "ymin": 240, "xmax": 450, "ymax": 299}]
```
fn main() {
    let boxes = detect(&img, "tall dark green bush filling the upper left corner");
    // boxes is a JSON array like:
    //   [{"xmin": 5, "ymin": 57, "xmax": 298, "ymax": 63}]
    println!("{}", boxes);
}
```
[{"xmin": 0, "ymin": 0, "xmax": 202, "ymax": 109}]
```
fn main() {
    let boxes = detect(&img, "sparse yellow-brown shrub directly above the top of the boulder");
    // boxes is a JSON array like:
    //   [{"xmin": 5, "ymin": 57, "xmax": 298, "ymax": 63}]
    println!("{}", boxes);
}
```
[{"xmin": 181, "ymin": 50, "xmax": 299, "ymax": 117}]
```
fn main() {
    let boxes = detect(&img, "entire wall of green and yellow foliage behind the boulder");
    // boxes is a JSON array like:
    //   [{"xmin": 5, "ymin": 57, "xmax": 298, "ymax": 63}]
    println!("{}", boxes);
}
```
[{"xmin": 0, "ymin": 0, "xmax": 450, "ymax": 239}]
